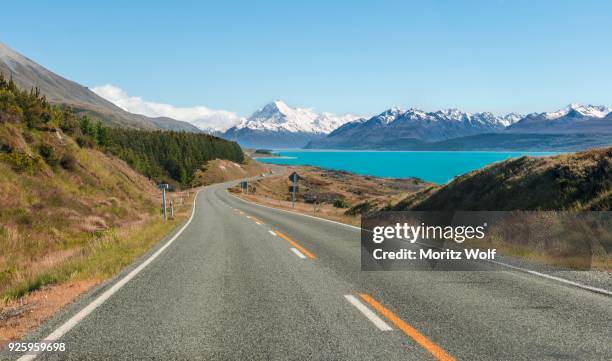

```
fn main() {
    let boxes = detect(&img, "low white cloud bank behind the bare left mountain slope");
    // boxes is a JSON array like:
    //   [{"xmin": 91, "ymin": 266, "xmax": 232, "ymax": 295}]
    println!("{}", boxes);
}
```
[{"xmin": 92, "ymin": 84, "xmax": 243, "ymax": 131}]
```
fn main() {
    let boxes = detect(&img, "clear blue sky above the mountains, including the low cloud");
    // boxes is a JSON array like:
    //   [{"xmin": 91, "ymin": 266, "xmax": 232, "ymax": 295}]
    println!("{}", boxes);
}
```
[{"xmin": 0, "ymin": 0, "xmax": 612, "ymax": 129}]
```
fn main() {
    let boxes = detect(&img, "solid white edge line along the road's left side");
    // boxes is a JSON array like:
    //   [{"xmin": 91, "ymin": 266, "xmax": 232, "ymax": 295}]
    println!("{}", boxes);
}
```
[{"xmin": 17, "ymin": 191, "xmax": 200, "ymax": 361}]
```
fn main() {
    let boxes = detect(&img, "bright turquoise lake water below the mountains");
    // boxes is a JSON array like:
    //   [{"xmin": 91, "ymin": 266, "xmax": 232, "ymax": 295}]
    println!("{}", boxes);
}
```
[{"xmin": 257, "ymin": 151, "xmax": 558, "ymax": 184}]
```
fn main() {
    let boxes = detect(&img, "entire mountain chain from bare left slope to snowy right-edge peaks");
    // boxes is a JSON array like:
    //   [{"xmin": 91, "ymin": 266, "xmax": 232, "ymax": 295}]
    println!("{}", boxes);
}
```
[{"xmin": 0, "ymin": 43, "xmax": 612, "ymax": 151}]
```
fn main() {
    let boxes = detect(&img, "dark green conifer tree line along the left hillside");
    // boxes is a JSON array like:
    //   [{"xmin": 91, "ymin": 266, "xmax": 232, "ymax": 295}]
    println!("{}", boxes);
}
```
[{"xmin": 0, "ymin": 74, "xmax": 244, "ymax": 186}]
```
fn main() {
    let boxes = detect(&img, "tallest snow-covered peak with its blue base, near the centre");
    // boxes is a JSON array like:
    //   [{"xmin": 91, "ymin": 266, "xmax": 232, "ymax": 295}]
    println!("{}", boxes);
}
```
[{"xmin": 223, "ymin": 100, "xmax": 356, "ymax": 148}]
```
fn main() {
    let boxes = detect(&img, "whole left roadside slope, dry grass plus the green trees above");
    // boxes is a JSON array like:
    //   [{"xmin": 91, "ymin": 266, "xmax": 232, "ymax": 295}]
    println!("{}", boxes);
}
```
[{"xmin": 0, "ymin": 76, "xmax": 206, "ymax": 300}]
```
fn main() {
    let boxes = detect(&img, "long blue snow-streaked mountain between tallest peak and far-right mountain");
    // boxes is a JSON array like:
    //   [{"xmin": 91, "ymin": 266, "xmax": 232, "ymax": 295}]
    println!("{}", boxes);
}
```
[{"xmin": 307, "ymin": 108, "xmax": 522, "ymax": 149}]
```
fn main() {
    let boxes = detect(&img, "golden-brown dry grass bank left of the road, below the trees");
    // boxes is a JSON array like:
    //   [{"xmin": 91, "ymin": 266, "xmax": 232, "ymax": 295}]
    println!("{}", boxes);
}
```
[{"xmin": 0, "ymin": 124, "xmax": 195, "ymax": 302}]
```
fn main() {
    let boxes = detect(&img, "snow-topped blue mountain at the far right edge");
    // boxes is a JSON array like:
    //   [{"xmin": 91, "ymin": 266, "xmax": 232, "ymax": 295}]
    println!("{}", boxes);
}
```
[{"xmin": 506, "ymin": 104, "xmax": 612, "ymax": 134}]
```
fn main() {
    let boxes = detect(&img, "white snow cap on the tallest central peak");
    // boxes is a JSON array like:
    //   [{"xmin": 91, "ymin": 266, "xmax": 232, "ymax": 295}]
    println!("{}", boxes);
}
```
[{"xmin": 236, "ymin": 100, "xmax": 358, "ymax": 134}]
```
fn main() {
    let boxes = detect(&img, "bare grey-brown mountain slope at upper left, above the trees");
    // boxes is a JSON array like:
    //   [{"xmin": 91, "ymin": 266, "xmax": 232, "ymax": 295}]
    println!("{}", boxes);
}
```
[{"xmin": 0, "ymin": 43, "xmax": 200, "ymax": 132}]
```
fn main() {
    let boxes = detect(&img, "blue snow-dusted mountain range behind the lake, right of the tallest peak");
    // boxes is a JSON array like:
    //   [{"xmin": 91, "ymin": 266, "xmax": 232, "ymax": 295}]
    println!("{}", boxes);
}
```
[{"xmin": 306, "ymin": 104, "xmax": 612, "ymax": 151}]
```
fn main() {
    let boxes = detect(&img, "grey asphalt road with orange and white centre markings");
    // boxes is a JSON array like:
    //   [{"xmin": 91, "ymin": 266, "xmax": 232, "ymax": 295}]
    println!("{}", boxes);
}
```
[{"xmin": 5, "ymin": 184, "xmax": 612, "ymax": 360}]
